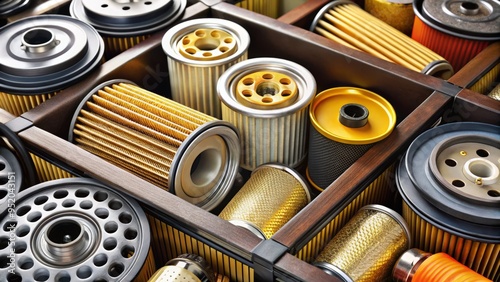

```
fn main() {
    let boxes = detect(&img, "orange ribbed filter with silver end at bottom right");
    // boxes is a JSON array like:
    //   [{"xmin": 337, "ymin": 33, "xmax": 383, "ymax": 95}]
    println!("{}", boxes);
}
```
[{"xmin": 392, "ymin": 248, "xmax": 491, "ymax": 282}]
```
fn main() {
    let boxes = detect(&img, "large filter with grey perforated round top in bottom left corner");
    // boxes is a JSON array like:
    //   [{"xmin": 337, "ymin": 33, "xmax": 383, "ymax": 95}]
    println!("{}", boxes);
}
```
[{"xmin": 0, "ymin": 178, "xmax": 154, "ymax": 281}]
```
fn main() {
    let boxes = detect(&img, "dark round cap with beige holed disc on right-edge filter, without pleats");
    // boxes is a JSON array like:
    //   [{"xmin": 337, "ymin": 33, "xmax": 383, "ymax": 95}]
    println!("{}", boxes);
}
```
[{"xmin": 397, "ymin": 122, "xmax": 500, "ymax": 236}]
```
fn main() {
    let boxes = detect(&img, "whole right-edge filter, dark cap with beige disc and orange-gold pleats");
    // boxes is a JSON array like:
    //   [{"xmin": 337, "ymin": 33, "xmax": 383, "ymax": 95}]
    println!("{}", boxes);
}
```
[{"xmin": 396, "ymin": 122, "xmax": 500, "ymax": 281}]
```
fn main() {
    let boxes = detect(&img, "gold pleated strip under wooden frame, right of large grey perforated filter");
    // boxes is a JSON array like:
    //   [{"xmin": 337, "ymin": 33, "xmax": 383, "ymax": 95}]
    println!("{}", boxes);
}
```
[{"xmin": 148, "ymin": 214, "xmax": 254, "ymax": 282}]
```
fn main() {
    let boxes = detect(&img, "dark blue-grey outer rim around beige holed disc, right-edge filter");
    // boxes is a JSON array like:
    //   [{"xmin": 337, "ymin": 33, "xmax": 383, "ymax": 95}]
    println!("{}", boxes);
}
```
[{"xmin": 396, "ymin": 122, "xmax": 500, "ymax": 243}]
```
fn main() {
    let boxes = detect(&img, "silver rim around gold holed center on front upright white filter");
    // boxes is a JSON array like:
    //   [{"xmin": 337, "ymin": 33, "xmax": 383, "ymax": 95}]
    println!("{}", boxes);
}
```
[{"xmin": 217, "ymin": 58, "xmax": 316, "ymax": 118}]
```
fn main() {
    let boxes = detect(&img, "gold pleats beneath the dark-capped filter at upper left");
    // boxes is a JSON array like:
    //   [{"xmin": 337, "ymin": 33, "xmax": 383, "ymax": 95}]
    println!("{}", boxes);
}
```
[{"xmin": 0, "ymin": 91, "xmax": 57, "ymax": 116}]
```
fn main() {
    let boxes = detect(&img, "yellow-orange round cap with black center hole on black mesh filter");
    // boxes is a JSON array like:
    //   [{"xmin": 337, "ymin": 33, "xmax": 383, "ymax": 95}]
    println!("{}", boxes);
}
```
[{"xmin": 309, "ymin": 87, "xmax": 396, "ymax": 145}]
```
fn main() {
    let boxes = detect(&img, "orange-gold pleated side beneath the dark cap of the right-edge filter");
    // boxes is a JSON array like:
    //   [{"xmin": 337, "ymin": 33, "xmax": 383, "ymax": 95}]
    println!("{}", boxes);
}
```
[{"xmin": 402, "ymin": 202, "xmax": 500, "ymax": 281}]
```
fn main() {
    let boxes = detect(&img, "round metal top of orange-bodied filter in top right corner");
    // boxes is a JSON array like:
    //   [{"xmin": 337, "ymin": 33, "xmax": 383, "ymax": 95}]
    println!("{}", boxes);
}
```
[{"xmin": 414, "ymin": 0, "xmax": 500, "ymax": 40}]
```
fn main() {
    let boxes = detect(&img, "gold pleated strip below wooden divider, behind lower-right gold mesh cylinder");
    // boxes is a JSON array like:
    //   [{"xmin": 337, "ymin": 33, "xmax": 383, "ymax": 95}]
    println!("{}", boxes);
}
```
[{"xmin": 296, "ymin": 165, "xmax": 395, "ymax": 263}]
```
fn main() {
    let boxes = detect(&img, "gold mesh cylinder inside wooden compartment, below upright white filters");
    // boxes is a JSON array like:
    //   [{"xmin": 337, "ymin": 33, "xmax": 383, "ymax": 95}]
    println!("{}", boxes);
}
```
[{"xmin": 219, "ymin": 164, "xmax": 311, "ymax": 239}]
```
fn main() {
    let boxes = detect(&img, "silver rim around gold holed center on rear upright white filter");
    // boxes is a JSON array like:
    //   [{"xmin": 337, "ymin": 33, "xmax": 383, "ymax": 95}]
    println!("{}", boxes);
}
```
[{"xmin": 161, "ymin": 18, "xmax": 250, "ymax": 67}]
